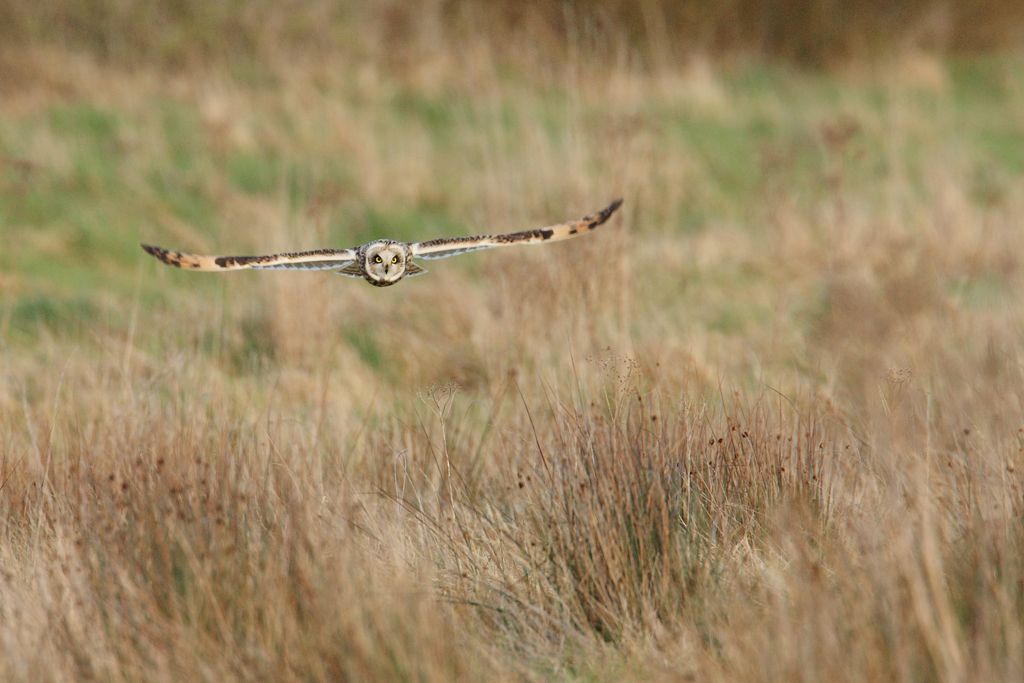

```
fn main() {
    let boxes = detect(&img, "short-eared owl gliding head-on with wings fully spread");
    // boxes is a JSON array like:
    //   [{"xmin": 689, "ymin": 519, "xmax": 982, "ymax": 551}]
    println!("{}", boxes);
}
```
[{"xmin": 142, "ymin": 200, "xmax": 623, "ymax": 287}]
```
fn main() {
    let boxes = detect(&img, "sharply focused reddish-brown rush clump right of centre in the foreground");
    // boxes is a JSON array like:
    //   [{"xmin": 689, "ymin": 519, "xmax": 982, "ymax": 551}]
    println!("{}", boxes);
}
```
[{"xmin": 386, "ymin": 384, "xmax": 839, "ymax": 661}]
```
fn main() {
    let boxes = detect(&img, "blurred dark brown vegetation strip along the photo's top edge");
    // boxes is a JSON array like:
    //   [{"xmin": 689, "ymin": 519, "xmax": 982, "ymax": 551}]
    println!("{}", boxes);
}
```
[{"xmin": 0, "ymin": 0, "xmax": 1024, "ymax": 68}]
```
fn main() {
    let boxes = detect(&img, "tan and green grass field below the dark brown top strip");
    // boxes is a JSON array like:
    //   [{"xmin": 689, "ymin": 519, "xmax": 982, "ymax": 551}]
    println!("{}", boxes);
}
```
[{"xmin": 0, "ymin": 3, "xmax": 1024, "ymax": 681}]
